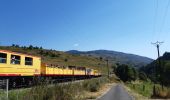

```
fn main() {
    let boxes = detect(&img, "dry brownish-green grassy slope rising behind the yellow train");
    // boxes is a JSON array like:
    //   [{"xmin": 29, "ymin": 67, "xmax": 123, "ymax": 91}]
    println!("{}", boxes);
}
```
[{"xmin": 0, "ymin": 46, "xmax": 107, "ymax": 73}]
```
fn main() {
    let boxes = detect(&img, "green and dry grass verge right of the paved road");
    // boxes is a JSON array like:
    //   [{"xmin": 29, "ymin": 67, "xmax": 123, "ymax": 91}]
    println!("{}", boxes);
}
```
[{"xmin": 125, "ymin": 82, "xmax": 170, "ymax": 100}]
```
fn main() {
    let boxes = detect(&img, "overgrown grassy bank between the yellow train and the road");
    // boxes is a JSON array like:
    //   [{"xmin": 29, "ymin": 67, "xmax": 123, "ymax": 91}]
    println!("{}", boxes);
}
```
[{"xmin": 0, "ymin": 77, "xmax": 120, "ymax": 100}]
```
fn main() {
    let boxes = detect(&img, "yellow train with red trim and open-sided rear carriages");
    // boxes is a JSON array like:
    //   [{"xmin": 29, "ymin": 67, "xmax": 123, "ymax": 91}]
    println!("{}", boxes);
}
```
[{"xmin": 0, "ymin": 50, "xmax": 101, "ymax": 87}]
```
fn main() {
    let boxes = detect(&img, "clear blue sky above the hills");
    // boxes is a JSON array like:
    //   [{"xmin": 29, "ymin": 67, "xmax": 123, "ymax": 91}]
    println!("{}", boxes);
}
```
[{"xmin": 0, "ymin": 0, "xmax": 170, "ymax": 58}]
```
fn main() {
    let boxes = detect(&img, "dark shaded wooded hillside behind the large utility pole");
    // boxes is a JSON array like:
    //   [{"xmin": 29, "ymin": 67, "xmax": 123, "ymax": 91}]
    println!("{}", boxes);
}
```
[{"xmin": 140, "ymin": 52, "xmax": 170, "ymax": 85}]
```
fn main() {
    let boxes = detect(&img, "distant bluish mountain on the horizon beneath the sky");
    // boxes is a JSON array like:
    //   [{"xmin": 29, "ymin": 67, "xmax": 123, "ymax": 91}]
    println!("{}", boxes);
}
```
[{"xmin": 66, "ymin": 50, "xmax": 153, "ymax": 68}]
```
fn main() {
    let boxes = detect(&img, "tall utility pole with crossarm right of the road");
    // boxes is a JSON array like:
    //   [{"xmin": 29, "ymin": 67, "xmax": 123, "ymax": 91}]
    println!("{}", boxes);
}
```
[{"xmin": 152, "ymin": 41, "xmax": 164, "ymax": 90}]
